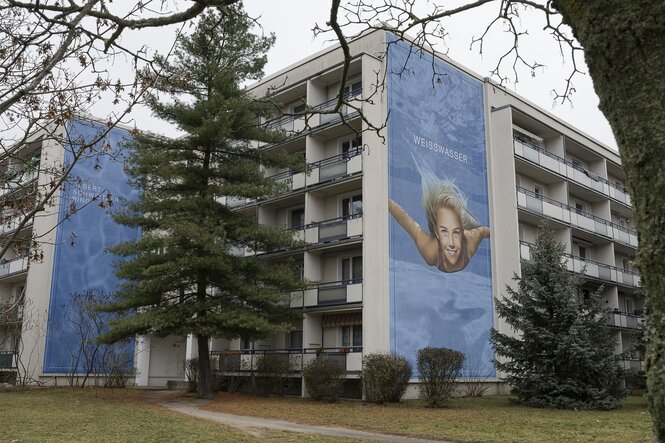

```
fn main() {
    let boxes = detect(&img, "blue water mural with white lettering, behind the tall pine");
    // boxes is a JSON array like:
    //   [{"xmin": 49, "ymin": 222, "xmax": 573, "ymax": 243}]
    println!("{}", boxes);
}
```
[{"xmin": 44, "ymin": 120, "xmax": 139, "ymax": 373}]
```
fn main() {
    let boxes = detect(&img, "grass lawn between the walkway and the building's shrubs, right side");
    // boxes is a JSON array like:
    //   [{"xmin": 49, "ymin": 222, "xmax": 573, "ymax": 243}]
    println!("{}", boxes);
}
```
[{"xmin": 205, "ymin": 394, "xmax": 652, "ymax": 443}]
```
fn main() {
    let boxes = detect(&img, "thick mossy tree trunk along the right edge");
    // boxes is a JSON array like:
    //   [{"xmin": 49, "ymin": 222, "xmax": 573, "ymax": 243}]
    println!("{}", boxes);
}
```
[{"xmin": 556, "ymin": 0, "xmax": 665, "ymax": 442}]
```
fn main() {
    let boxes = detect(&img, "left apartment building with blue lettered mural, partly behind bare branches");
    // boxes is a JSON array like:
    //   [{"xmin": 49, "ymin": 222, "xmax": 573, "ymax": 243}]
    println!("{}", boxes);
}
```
[{"xmin": 0, "ymin": 118, "xmax": 138, "ymax": 384}]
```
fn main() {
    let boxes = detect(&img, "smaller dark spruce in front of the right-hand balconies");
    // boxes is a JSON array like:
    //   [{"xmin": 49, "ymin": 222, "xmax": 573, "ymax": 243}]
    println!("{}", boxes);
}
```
[{"xmin": 492, "ymin": 226, "xmax": 624, "ymax": 409}]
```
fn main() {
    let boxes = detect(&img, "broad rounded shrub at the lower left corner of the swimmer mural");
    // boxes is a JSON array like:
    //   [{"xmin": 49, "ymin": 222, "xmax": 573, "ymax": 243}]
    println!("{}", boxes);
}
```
[{"xmin": 362, "ymin": 354, "xmax": 413, "ymax": 403}]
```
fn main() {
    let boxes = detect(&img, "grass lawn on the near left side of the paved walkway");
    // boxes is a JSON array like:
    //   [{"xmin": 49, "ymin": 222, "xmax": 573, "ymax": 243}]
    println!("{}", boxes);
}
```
[{"xmin": 0, "ymin": 388, "xmax": 358, "ymax": 443}]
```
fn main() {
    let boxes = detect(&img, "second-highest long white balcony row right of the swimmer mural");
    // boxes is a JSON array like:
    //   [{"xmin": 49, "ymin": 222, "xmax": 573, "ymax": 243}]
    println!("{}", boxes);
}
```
[{"xmin": 517, "ymin": 186, "xmax": 637, "ymax": 248}]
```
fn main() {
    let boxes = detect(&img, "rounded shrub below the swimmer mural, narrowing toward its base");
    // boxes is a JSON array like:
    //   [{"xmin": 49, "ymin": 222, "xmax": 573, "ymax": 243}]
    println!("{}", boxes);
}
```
[{"xmin": 418, "ymin": 347, "xmax": 464, "ymax": 408}]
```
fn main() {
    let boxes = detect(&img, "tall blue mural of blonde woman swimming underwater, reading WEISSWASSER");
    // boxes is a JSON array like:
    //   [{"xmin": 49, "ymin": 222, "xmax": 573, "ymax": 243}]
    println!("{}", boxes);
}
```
[{"xmin": 387, "ymin": 35, "xmax": 496, "ymax": 377}]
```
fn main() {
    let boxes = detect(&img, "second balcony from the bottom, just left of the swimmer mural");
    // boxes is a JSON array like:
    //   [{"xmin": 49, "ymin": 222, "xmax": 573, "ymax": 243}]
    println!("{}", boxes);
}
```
[{"xmin": 291, "ymin": 278, "xmax": 363, "ymax": 308}]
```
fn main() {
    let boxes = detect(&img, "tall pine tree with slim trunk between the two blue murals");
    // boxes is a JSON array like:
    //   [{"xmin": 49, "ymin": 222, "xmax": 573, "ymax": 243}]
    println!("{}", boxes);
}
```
[{"xmin": 101, "ymin": 4, "xmax": 303, "ymax": 397}]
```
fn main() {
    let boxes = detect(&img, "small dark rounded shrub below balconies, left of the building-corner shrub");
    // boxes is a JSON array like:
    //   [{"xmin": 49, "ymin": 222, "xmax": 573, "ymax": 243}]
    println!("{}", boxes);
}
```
[{"xmin": 303, "ymin": 355, "xmax": 344, "ymax": 402}]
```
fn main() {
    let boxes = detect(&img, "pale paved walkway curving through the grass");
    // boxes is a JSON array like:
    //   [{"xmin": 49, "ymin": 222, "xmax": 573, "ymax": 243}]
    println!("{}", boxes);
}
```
[{"xmin": 155, "ymin": 396, "xmax": 445, "ymax": 443}]
